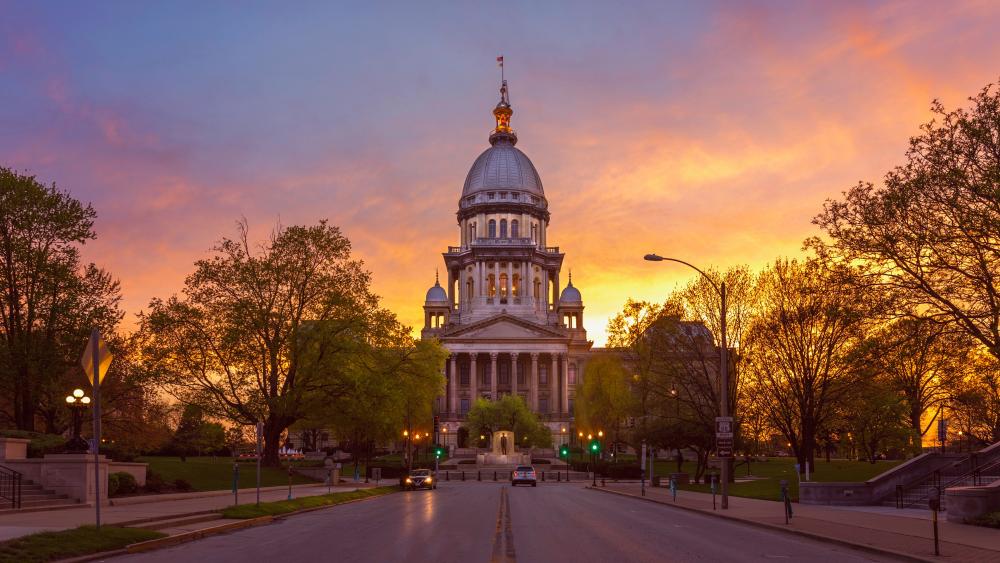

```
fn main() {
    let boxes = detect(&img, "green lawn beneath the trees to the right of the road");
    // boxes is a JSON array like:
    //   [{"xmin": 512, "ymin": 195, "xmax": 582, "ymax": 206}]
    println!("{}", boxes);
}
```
[{"xmin": 656, "ymin": 457, "xmax": 902, "ymax": 501}]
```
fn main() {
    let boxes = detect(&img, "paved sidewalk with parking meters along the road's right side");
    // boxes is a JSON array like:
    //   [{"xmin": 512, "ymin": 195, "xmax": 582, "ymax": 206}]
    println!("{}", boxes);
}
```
[{"xmin": 598, "ymin": 483, "xmax": 1000, "ymax": 561}]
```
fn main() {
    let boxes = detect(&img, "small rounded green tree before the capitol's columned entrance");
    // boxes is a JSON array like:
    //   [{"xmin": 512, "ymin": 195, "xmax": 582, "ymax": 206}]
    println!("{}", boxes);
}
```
[{"xmin": 465, "ymin": 395, "xmax": 552, "ymax": 448}]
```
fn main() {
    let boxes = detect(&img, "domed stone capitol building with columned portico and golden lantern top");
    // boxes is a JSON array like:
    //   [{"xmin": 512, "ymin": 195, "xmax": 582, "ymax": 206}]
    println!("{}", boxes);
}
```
[{"xmin": 421, "ymin": 81, "xmax": 593, "ymax": 445}]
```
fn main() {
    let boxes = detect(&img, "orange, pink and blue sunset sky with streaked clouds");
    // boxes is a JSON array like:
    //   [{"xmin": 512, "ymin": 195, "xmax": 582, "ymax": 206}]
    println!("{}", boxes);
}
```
[{"xmin": 0, "ymin": 0, "xmax": 1000, "ymax": 346}]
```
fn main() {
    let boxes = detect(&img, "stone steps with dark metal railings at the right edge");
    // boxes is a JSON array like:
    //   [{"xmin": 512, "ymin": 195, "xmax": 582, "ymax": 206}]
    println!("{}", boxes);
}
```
[{"xmin": 895, "ymin": 444, "xmax": 1000, "ymax": 510}]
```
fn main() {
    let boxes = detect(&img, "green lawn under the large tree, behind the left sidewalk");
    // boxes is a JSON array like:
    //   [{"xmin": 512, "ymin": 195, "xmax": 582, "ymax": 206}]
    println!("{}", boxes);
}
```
[{"xmin": 138, "ymin": 456, "xmax": 315, "ymax": 491}]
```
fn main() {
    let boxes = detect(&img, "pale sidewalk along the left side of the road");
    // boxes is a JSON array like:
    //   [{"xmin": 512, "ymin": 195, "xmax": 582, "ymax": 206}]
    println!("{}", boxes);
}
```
[{"xmin": 0, "ymin": 481, "xmax": 375, "ymax": 541}]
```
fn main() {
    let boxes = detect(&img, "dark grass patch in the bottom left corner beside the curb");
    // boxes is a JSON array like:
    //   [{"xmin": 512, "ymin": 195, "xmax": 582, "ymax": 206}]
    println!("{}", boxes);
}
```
[{"xmin": 0, "ymin": 526, "xmax": 166, "ymax": 563}]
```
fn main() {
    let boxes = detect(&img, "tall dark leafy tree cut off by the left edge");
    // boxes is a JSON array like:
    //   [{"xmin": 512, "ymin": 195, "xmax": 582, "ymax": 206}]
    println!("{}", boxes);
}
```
[{"xmin": 0, "ymin": 167, "xmax": 122, "ymax": 432}]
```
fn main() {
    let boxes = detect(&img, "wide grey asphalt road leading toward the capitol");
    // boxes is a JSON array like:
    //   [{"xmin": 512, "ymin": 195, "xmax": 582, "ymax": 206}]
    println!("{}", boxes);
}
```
[{"xmin": 116, "ymin": 483, "xmax": 892, "ymax": 563}]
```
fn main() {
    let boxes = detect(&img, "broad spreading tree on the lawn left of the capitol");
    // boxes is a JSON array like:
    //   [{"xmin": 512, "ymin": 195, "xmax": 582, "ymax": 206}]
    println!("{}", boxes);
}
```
[{"xmin": 140, "ymin": 221, "xmax": 385, "ymax": 465}]
